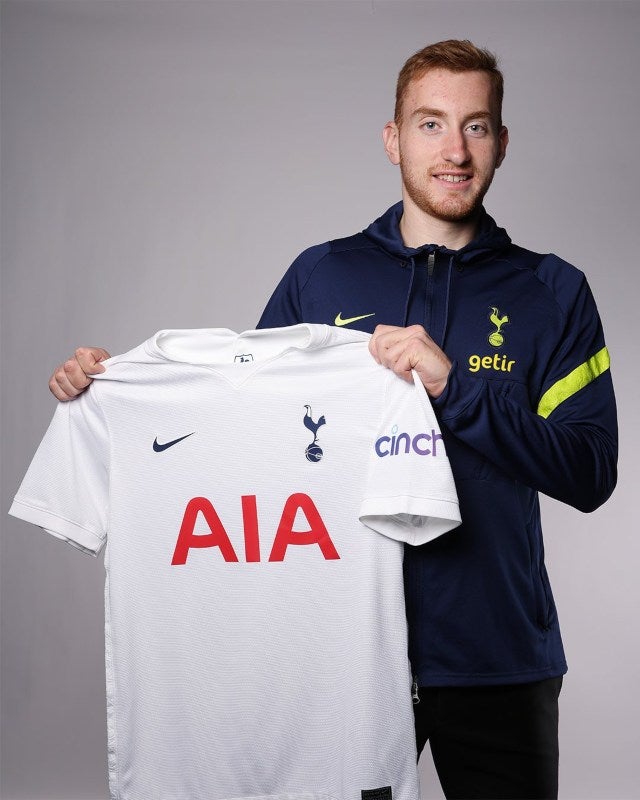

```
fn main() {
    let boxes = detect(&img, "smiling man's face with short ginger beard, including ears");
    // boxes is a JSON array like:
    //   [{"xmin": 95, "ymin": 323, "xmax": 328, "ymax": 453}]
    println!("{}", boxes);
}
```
[{"xmin": 383, "ymin": 69, "xmax": 508, "ymax": 222}]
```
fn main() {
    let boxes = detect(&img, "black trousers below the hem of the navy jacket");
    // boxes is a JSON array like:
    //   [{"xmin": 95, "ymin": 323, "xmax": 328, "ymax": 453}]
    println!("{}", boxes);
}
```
[{"xmin": 414, "ymin": 678, "xmax": 562, "ymax": 800}]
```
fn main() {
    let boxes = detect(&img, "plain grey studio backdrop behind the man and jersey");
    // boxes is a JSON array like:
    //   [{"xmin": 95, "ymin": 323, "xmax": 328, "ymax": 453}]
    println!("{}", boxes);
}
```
[{"xmin": 1, "ymin": 0, "xmax": 640, "ymax": 800}]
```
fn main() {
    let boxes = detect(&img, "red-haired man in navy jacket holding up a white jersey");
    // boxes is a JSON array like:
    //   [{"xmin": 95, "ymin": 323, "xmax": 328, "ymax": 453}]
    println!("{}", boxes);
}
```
[{"xmin": 50, "ymin": 41, "xmax": 617, "ymax": 799}]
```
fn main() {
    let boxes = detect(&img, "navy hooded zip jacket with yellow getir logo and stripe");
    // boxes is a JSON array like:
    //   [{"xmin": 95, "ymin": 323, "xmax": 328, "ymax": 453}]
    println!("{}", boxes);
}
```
[{"xmin": 259, "ymin": 203, "xmax": 617, "ymax": 686}]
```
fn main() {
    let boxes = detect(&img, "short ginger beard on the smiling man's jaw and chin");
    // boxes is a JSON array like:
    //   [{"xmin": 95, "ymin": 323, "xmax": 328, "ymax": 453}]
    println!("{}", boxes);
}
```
[{"xmin": 400, "ymin": 155, "xmax": 495, "ymax": 222}]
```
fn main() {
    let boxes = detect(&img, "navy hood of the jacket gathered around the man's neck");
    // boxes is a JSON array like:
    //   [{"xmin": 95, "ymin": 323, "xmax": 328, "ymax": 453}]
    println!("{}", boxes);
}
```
[{"xmin": 363, "ymin": 201, "xmax": 511, "ymax": 264}]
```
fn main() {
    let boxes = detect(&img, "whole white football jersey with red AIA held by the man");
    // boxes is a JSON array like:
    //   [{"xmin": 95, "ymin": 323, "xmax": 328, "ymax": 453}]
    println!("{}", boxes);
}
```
[{"xmin": 10, "ymin": 325, "xmax": 460, "ymax": 800}]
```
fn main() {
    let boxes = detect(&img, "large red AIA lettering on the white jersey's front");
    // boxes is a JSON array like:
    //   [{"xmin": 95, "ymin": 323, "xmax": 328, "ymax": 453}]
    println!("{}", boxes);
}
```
[{"xmin": 171, "ymin": 493, "xmax": 340, "ymax": 566}]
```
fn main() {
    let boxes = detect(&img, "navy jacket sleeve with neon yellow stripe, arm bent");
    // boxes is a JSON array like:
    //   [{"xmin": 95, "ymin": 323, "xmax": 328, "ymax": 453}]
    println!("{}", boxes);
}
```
[{"xmin": 434, "ymin": 271, "xmax": 618, "ymax": 511}]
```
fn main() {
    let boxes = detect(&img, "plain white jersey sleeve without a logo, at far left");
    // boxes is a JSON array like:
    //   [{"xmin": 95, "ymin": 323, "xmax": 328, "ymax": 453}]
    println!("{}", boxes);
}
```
[{"xmin": 9, "ymin": 387, "xmax": 109, "ymax": 556}]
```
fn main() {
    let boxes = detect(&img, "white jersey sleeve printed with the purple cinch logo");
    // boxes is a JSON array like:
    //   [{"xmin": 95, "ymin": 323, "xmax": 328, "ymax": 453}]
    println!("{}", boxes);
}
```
[{"xmin": 359, "ymin": 372, "xmax": 460, "ymax": 545}]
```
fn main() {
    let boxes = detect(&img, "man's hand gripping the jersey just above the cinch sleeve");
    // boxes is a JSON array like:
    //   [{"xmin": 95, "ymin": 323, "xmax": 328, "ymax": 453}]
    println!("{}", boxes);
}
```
[{"xmin": 369, "ymin": 325, "xmax": 451, "ymax": 399}]
